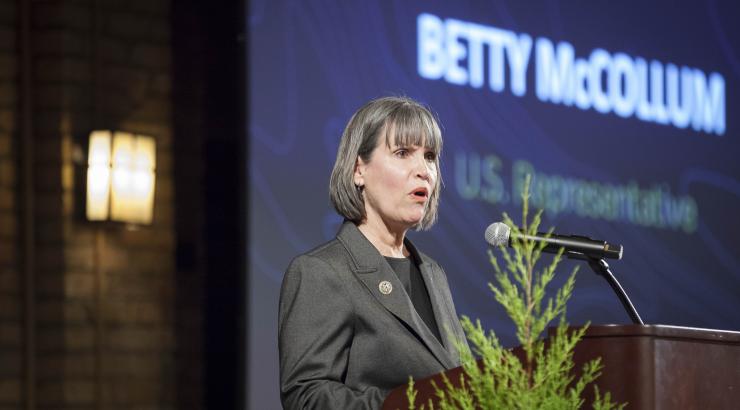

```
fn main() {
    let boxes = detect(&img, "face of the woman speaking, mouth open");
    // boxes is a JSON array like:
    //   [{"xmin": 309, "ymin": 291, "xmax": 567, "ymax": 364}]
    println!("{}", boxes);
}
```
[{"xmin": 354, "ymin": 133, "xmax": 438, "ymax": 230}]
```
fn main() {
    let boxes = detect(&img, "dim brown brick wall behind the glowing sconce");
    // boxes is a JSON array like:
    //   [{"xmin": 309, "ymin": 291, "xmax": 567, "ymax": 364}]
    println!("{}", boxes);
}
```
[{"xmin": 0, "ymin": 0, "xmax": 202, "ymax": 409}]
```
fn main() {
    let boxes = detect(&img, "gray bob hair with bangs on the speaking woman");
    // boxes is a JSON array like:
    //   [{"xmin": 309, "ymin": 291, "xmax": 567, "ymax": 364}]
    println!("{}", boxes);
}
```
[{"xmin": 329, "ymin": 97, "xmax": 442, "ymax": 230}]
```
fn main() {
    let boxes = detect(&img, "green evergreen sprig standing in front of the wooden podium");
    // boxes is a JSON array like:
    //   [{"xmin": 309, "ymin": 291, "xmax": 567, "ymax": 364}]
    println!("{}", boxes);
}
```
[{"xmin": 407, "ymin": 176, "xmax": 624, "ymax": 410}]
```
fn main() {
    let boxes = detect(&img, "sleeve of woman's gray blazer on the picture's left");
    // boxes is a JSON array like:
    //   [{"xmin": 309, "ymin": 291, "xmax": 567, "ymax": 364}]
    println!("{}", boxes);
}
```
[{"xmin": 278, "ymin": 255, "xmax": 384, "ymax": 410}]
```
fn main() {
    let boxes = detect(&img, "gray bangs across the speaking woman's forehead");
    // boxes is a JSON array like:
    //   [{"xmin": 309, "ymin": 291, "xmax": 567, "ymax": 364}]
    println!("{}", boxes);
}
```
[{"xmin": 385, "ymin": 104, "xmax": 442, "ymax": 155}]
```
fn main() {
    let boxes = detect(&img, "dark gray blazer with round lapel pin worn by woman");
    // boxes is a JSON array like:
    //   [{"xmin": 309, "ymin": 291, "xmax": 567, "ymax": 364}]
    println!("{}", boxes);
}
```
[{"xmin": 278, "ymin": 222, "xmax": 467, "ymax": 410}]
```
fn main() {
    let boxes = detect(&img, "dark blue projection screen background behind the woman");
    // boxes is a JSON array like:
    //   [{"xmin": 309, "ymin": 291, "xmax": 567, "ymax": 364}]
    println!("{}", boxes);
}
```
[{"xmin": 245, "ymin": 0, "xmax": 740, "ymax": 409}]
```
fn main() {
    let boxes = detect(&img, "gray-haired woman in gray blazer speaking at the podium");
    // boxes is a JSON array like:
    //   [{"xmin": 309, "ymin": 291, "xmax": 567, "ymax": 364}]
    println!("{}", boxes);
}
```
[{"xmin": 278, "ymin": 97, "xmax": 467, "ymax": 409}]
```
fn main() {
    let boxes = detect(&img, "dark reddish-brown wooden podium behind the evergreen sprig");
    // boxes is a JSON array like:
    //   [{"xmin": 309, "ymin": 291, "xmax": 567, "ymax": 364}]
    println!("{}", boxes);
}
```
[{"xmin": 383, "ymin": 325, "xmax": 740, "ymax": 410}]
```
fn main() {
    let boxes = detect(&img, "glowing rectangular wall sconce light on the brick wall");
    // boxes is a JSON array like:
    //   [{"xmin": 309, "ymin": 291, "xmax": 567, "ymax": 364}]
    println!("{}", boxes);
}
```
[{"xmin": 85, "ymin": 130, "xmax": 156, "ymax": 225}]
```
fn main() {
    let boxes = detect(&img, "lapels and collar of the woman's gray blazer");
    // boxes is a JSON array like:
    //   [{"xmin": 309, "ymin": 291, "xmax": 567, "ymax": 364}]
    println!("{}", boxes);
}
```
[{"xmin": 337, "ymin": 221, "xmax": 459, "ymax": 369}]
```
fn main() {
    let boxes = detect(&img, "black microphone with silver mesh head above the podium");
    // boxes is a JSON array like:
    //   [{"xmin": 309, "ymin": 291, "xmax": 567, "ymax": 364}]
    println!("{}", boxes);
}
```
[{"xmin": 486, "ymin": 222, "xmax": 622, "ymax": 259}]
